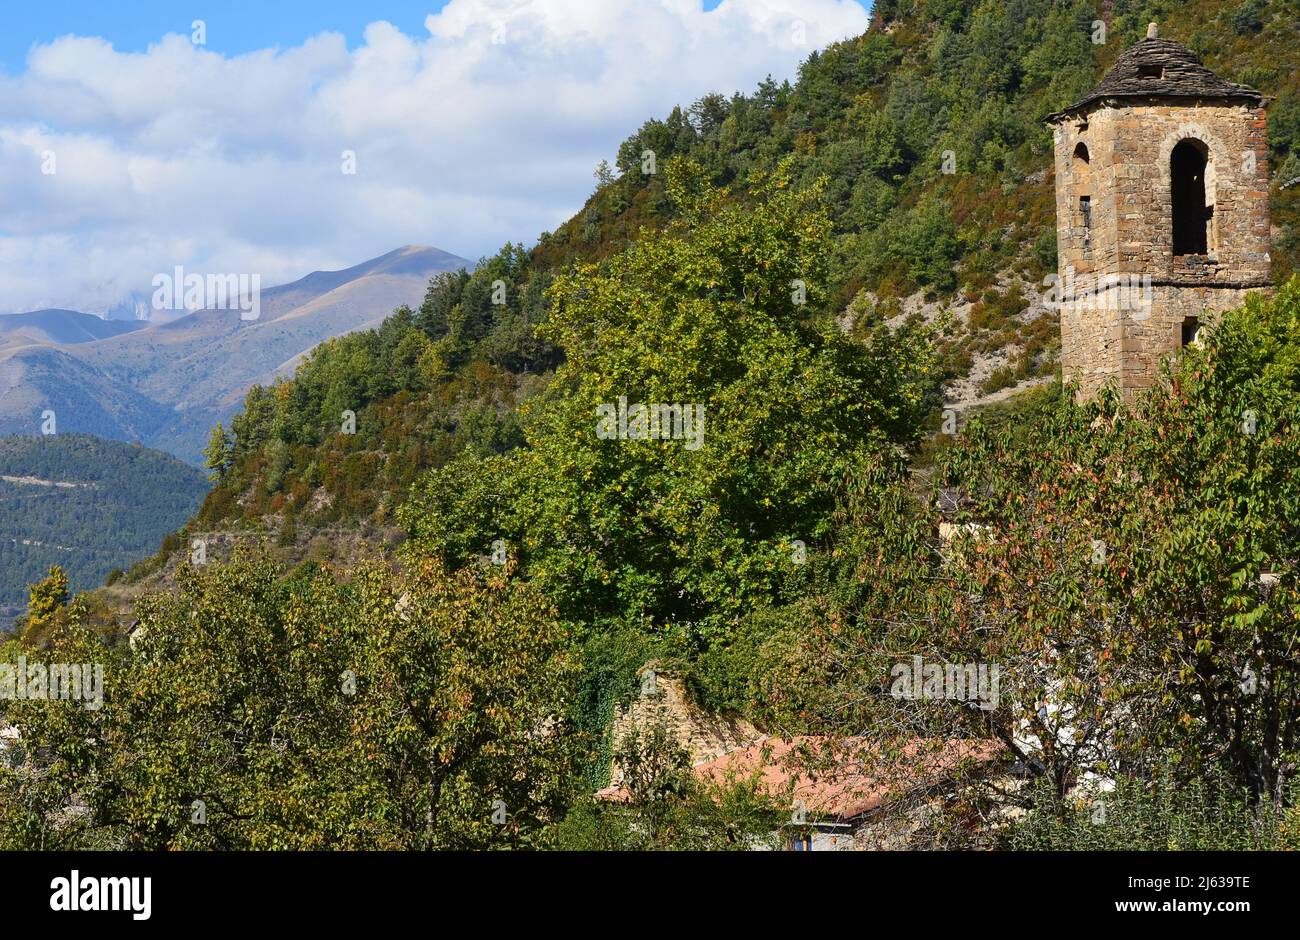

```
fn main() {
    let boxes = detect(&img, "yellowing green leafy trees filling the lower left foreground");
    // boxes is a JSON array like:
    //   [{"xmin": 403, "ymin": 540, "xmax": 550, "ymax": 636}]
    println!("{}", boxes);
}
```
[{"xmin": 0, "ymin": 558, "xmax": 576, "ymax": 849}]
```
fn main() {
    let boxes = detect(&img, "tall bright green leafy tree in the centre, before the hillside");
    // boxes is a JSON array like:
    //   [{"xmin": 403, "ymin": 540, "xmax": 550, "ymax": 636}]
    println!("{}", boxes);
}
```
[{"xmin": 404, "ymin": 159, "xmax": 930, "ymax": 663}]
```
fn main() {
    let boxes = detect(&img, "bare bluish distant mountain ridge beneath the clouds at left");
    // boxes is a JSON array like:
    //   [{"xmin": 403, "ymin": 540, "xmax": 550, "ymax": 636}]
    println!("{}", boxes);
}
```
[{"xmin": 0, "ymin": 246, "xmax": 473, "ymax": 464}]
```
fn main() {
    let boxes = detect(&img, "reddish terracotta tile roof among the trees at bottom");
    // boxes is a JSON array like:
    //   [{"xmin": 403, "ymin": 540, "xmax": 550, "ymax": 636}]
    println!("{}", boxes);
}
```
[{"xmin": 595, "ymin": 736, "xmax": 1001, "ymax": 819}]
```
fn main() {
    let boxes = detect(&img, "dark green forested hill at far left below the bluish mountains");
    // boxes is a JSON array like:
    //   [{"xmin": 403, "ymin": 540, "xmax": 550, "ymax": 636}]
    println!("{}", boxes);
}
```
[{"xmin": 0, "ymin": 434, "xmax": 208, "ymax": 628}]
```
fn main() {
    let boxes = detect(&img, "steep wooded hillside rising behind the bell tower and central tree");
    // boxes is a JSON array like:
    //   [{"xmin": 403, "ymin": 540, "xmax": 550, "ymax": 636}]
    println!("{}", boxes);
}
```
[{"xmin": 180, "ymin": 0, "xmax": 1300, "ymax": 543}]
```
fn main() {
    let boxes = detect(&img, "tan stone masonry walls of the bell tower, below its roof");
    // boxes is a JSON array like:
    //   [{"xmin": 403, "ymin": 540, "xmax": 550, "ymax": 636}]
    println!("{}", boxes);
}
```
[{"xmin": 1054, "ymin": 100, "xmax": 1269, "ymax": 398}]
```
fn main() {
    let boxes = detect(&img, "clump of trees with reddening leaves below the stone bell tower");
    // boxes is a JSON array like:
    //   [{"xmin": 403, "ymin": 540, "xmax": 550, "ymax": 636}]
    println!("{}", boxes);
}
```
[{"xmin": 766, "ymin": 282, "xmax": 1300, "ymax": 805}]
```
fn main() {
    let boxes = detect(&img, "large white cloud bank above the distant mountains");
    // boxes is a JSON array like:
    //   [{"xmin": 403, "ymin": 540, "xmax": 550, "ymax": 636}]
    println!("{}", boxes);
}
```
[{"xmin": 0, "ymin": 0, "xmax": 867, "ymax": 311}]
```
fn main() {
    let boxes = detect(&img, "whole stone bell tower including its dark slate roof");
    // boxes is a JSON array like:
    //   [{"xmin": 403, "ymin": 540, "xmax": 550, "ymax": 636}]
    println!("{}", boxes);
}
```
[{"xmin": 1048, "ymin": 23, "xmax": 1270, "ymax": 398}]
